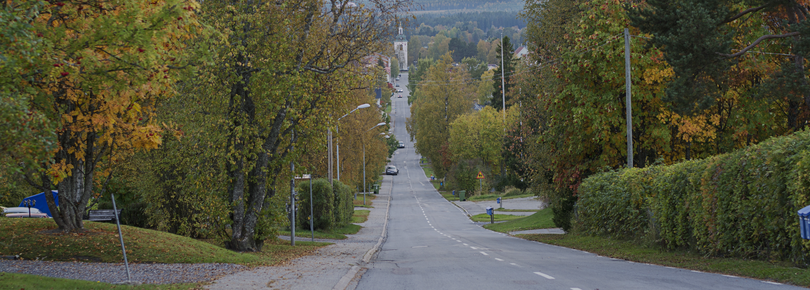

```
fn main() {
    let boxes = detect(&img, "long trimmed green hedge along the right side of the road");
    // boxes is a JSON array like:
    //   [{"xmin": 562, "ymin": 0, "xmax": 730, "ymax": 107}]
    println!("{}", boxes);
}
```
[{"xmin": 576, "ymin": 131, "xmax": 810, "ymax": 264}]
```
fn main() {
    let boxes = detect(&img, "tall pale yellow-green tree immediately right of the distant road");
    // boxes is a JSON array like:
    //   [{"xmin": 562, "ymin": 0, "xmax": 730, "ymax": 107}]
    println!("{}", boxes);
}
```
[{"xmin": 409, "ymin": 53, "xmax": 474, "ymax": 178}]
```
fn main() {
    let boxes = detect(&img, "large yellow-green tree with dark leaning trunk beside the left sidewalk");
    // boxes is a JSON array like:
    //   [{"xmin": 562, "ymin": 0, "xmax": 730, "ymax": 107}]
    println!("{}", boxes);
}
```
[{"xmin": 200, "ymin": 0, "xmax": 407, "ymax": 251}]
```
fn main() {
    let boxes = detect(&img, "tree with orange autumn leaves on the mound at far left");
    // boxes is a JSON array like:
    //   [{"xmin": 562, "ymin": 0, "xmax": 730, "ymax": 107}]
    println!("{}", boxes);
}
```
[{"xmin": 13, "ymin": 0, "xmax": 197, "ymax": 232}]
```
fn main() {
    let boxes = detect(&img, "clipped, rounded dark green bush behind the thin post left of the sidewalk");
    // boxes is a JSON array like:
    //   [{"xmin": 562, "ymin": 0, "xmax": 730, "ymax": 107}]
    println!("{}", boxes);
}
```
[{"xmin": 296, "ymin": 179, "xmax": 335, "ymax": 230}]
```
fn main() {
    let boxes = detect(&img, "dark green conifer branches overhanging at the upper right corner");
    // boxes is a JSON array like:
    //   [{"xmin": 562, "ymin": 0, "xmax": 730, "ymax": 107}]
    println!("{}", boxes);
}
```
[{"xmin": 625, "ymin": 0, "xmax": 810, "ymax": 130}]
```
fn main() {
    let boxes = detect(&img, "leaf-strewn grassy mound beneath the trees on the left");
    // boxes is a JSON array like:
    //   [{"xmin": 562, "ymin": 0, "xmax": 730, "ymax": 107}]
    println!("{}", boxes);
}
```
[{"xmin": 0, "ymin": 218, "xmax": 328, "ymax": 266}]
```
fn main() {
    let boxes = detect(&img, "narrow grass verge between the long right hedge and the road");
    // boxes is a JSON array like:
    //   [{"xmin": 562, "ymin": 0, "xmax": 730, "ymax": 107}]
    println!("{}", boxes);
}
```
[{"xmin": 518, "ymin": 234, "xmax": 810, "ymax": 287}]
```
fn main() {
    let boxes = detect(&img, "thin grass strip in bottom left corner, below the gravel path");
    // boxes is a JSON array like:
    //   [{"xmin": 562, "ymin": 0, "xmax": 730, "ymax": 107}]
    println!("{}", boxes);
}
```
[{"xmin": 0, "ymin": 272, "xmax": 201, "ymax": 290}]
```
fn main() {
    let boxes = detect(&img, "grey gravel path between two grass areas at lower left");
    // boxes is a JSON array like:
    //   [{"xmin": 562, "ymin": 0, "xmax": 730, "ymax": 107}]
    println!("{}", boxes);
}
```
[{"xmin": 0, "ymin": 260, "xmax": 247, "ymax": 284}]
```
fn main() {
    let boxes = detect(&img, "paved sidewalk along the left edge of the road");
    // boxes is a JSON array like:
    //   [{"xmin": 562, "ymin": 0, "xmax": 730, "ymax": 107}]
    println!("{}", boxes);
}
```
[{"xmin": 206, "ymin": 176, "xmax": 392, "ymax": 290}]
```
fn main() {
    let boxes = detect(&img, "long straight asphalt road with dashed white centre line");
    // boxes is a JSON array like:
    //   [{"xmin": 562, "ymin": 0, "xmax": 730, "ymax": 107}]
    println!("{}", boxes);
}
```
[{"xmin": 357, "ymin": 73, "xmax": 805, "ymax": 290}]
